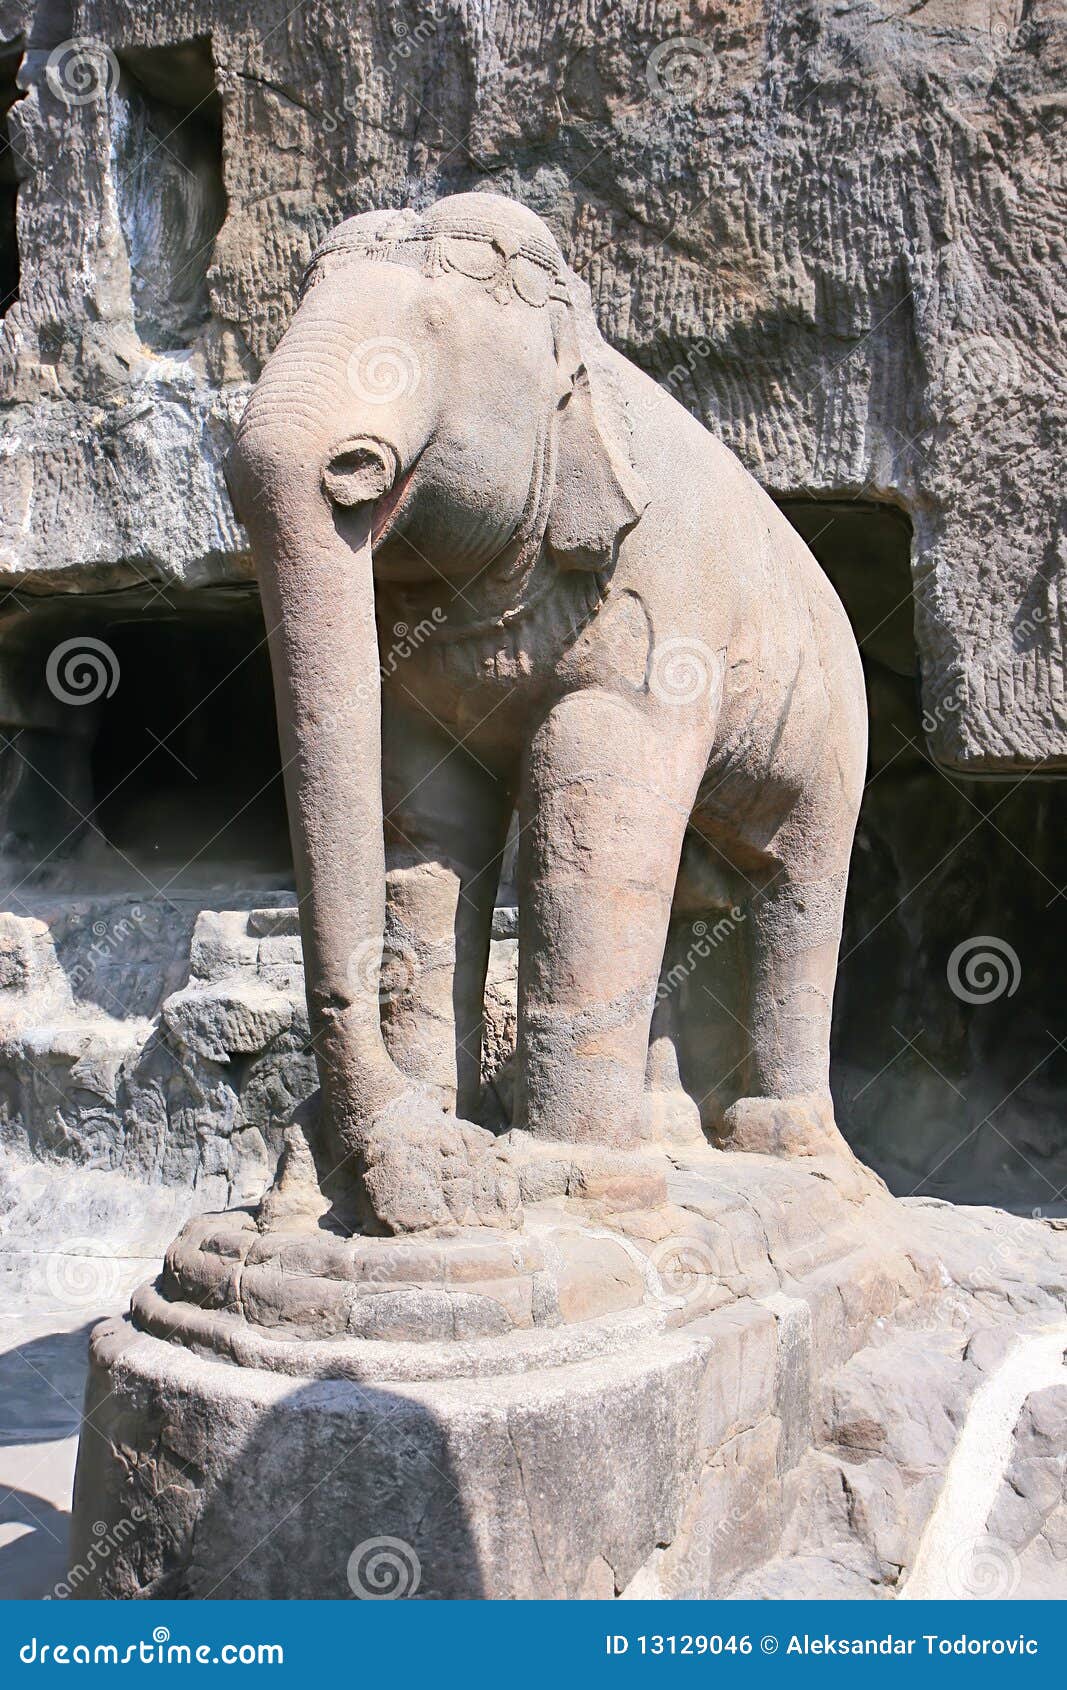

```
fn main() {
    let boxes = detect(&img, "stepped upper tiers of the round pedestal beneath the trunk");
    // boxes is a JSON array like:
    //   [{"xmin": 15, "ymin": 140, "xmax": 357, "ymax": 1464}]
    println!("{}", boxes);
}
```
[{"xmin": 132, "ymin": 1210, "xmax": 669, "ymax": 1377}]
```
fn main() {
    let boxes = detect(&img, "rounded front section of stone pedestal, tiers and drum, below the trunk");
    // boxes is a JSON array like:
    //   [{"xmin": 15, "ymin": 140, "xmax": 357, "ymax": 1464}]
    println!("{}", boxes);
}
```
[{"xmin": 71, "ymin": 1210, "xmax": 692, "ymax": 1599}]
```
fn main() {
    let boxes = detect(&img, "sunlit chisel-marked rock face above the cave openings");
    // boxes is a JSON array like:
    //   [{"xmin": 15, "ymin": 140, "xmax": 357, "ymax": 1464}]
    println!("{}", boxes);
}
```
[{"xmin": 0, "ymin": 0, "xmax": 1067, "ymax": 769}]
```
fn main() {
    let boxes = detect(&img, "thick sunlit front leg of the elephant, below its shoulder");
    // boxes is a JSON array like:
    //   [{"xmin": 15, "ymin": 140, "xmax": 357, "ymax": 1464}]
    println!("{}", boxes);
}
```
[{"xmin": 514, "ymin": 693, "xmax": 705, "ymax": 1148}]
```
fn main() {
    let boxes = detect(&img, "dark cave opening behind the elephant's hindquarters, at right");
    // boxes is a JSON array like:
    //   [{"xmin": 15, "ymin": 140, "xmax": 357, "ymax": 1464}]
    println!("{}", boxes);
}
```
[{"xmin": 781, "ymin": 500, "xmax": 1067, "ymax": 1212}]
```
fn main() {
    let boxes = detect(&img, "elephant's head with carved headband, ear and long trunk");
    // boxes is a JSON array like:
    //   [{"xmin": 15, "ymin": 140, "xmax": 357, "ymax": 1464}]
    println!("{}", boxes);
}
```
[{"xmin": 227, "ymin": 194, "xmax": 648, "ymax": 1230}]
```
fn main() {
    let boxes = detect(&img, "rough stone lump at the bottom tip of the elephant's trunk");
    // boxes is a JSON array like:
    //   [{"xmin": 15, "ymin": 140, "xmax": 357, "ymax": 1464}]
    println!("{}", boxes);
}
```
[{"xmin": 358, "ymin": 1095, "xmax": 523, "ymax": 1234}]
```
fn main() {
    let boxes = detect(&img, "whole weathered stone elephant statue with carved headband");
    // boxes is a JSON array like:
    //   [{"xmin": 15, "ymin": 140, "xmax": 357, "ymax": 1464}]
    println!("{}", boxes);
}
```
[{"xmin": 227, "ymin": 193, "xmax": 866, "ymax": 1232}]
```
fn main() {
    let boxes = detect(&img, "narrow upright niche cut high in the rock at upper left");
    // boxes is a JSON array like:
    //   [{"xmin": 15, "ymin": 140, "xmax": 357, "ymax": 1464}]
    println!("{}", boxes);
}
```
[{"xmin": 113, "ymin": 37, "xmax": 227, "ymax": 352}]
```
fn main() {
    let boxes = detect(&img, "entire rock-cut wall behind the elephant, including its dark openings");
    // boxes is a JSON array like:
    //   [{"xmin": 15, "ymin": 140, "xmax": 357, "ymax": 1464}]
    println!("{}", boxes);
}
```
[{"xmin": 0, "ymin": 0, "xmax": 1067, "ymax": 1207}]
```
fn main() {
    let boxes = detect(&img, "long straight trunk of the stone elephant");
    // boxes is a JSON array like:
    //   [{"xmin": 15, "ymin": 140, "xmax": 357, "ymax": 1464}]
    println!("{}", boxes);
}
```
[{"xmin": 227, "ymin": 398, "xmax": 404, "ymax": 1161}]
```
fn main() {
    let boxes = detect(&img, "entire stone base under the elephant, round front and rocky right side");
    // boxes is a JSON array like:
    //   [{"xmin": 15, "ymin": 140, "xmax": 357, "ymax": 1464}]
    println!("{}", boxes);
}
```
[{"xmin": 73, "ymin": 1149, "xmax": 1067, "ymax": 1599}]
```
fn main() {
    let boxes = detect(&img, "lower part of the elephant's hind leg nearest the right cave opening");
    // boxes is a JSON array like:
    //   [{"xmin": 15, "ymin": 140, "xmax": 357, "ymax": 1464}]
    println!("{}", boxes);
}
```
[{"xmin": 717, "ymin": 867, "xmax": 859, "ymax": 1156}]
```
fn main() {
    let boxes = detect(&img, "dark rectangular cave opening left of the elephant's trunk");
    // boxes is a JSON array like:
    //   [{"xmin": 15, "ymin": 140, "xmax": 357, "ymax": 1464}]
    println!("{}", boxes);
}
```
[{"xmin": 0, "ymin": 590, "xmax": 293, "ymax": 896}]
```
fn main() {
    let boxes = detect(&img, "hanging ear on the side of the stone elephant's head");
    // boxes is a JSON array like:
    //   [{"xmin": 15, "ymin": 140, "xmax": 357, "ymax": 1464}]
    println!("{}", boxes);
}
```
[{"xmin": 544, "ymin": 274, "xmax": 649, "ymax": 570}]
